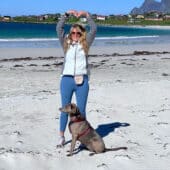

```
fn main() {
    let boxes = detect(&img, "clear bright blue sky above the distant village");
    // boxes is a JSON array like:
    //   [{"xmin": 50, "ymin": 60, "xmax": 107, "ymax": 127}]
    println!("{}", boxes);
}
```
[{"xmin": 0, "ymin": 0, "xmax": 159, "ymax": 16}]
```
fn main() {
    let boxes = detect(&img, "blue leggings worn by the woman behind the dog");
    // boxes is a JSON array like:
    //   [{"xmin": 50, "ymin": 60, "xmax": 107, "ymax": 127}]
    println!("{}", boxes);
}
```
[{"xmin": 60, "ymin": 75, "xmax": 89, "ymax": 132}]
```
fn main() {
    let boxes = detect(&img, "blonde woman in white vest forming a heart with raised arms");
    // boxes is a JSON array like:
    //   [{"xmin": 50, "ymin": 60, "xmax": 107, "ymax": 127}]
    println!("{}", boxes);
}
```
[{"xmin": 57, "ymin": 10, "xmax": 96, "ymax": 146}]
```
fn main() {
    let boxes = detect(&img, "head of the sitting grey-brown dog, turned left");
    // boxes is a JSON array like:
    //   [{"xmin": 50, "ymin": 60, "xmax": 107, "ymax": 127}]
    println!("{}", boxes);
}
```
[{"xmin": 59, "ymin": 103, "xmax": 80, "ymax": 116}]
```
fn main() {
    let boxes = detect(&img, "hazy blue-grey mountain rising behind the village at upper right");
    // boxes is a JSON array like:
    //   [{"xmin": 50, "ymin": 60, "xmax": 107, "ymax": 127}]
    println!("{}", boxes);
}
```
[{"xmin": 131, "ymin": 0, "xmax": 170, "ymax": 14}]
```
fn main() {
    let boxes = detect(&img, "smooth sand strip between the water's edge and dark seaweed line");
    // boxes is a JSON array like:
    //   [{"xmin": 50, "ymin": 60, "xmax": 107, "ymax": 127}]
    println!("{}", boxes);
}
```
[{"xmin": 0, "ymin": 43, "xmax": 170, "ymax": 60}]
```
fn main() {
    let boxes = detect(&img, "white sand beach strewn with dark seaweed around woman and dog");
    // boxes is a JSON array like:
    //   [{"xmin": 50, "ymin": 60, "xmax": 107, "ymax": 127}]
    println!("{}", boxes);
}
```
[{"xmin": 0, "ymin": 44, "xmax": 170, "ymax": 170}]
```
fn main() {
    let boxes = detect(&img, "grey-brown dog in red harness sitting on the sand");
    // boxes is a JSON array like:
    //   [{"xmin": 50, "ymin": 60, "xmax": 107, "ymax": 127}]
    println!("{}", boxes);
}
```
[{"xmin": 59, "ymin": 103, "xmax": 127, "ymax": 156}]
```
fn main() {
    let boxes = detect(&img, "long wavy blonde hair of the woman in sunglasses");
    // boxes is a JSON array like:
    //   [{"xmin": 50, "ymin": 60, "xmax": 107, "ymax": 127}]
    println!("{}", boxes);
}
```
[{"xmin": 64, "ymin": 24, "xmax": 89, "ymax": 56}]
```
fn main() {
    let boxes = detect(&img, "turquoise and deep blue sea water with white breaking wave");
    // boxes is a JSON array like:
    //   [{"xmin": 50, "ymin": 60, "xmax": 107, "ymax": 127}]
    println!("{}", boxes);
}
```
[{"xmin": 0, "ymin": 22, "xmax": 170, "ymax": 48}]
